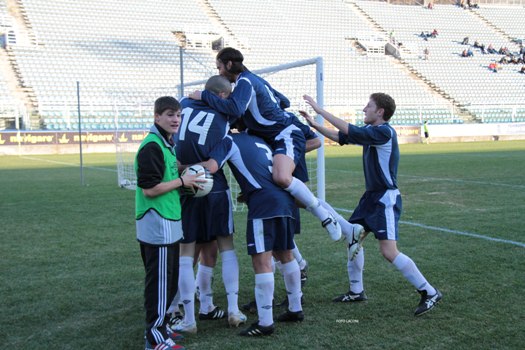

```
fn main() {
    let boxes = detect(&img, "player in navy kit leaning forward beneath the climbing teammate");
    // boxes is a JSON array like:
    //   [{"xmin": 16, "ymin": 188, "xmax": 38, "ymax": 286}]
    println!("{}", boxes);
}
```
[{"xmin": 203, "ymin": 132, "xmax": 304, "ymax": 336}]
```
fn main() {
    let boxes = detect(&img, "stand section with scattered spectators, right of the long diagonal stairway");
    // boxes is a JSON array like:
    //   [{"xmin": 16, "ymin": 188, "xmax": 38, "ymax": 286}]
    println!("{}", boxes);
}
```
[{"xmin": 356, "ymin": 1, "xmax": 525, "ymax": 121}]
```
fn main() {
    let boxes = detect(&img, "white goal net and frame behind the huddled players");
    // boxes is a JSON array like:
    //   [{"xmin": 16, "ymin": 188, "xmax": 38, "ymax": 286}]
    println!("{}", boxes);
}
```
[{"xmin": 115, "ymin": 57, "xmax": 325, "ymax": 211}]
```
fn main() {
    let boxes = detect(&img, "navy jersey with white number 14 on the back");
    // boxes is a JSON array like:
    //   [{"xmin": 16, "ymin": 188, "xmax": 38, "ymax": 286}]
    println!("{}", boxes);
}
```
[{"xmin": 177, "ymin": 98, "xmax": 230, "ymax": 192}]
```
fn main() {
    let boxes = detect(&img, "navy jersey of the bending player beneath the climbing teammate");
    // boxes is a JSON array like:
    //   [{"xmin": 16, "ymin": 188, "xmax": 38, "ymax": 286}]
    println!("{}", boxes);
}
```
[{"xmin": 212, "ymin": 133, "xmax": 295, "ymax": 219}]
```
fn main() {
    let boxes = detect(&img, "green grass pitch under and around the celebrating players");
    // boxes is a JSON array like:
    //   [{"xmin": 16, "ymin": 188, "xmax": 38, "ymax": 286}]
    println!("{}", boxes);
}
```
[{"xmin": 0, "ymin": 141, "xmax": 525, "ymax": 349}]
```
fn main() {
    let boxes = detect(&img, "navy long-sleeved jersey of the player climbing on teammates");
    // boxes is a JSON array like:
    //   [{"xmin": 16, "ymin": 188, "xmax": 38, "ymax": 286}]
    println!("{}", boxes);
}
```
[{"xmin": 201, "ymin": 71, "xmax": 292, "ymax": 140}]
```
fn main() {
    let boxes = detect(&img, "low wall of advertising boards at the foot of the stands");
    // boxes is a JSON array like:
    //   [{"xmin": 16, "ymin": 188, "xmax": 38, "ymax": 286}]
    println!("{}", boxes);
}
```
[{"xmin": 0, "ymin": 123, "xmax": 525, "ymax": 155}]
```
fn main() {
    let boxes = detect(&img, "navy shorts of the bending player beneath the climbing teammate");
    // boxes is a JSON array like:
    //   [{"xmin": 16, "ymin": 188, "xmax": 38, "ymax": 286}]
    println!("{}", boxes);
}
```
[{"xmin": 246, "ymin": 216, "xmax": 295, "ymax": 255}]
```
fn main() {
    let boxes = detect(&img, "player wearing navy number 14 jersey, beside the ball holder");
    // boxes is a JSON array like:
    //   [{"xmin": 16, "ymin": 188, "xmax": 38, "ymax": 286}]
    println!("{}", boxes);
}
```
[{"xmin": 172, "ymin": 75, "xmax": 246, "ymax": 333}]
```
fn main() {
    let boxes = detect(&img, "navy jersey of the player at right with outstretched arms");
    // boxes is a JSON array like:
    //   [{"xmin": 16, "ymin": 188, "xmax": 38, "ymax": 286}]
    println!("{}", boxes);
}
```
[{"xmin": 339, "ymin": 123, "xmax": 399, "ymax": 191}]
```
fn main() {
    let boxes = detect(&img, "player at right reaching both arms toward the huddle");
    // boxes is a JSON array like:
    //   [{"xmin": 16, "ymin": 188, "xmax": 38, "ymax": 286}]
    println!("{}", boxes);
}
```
[{"xmin": 300, "ymin": 93, "xmax": 442, "ymax": 316}]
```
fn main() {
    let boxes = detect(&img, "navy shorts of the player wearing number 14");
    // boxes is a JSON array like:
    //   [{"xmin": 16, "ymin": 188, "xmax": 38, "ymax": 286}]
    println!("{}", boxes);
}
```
[{"xmin": 180, "ymin": 190, "xmax": 234, "ymax": 243}]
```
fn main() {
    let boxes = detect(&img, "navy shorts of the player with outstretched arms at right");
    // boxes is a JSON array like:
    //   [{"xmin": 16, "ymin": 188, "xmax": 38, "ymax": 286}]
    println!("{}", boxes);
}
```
[{"xmin": 348, "ymin": 189, "xmax": 403, "ymax": 241}]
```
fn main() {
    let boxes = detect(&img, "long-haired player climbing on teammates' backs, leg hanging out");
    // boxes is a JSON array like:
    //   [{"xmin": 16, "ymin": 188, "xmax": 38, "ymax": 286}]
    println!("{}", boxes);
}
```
[{"xmin": 189, "ymin": 47, "xmax": 341, "ymax": 241}]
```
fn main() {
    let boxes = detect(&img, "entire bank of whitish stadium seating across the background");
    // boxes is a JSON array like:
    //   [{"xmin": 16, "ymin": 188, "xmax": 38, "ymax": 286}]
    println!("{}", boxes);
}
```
[{"xmin": 0, "ymin": 0, "xmax": 525, "ymax": 130}]
